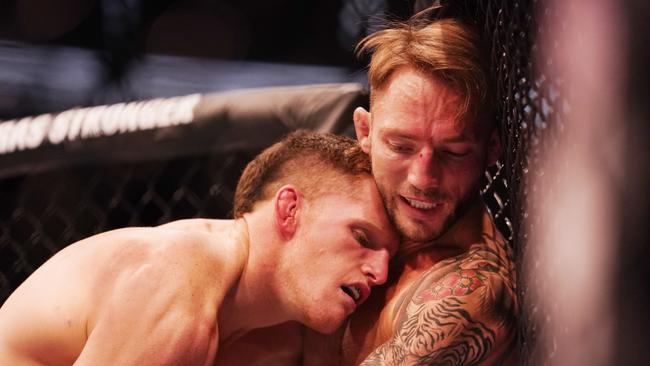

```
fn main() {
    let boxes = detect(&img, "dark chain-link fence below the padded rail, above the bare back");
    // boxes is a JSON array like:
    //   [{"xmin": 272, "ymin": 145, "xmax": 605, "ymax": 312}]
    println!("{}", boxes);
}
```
[{"xmin": 0, "ymin": 152, "xmax": 254, "ymax": 301}]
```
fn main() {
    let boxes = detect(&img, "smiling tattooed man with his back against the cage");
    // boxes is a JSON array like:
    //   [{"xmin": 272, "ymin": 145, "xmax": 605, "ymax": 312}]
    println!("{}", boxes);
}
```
[{"xmin": 298, "ymin": 13, "xmax": 517, "ymax": 366}]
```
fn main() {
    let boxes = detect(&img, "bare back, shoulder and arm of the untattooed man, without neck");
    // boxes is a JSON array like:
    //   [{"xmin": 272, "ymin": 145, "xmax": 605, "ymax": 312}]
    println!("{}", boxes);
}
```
[{"xmin": 0, "ymin": 220, "xmax": 246, "ymax": 365}]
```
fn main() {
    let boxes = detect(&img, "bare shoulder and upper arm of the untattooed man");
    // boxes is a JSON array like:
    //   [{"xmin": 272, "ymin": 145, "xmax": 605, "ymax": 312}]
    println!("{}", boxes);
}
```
[{"xmin": 79, "ymin": 227, "xmax": 240, "ymax": 365}]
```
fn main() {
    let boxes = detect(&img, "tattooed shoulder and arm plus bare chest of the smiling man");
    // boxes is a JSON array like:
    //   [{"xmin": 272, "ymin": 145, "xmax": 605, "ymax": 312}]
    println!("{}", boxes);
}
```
[{"xmin": 342, "ymin": 207, "xmax": 516, "ymax": 365}]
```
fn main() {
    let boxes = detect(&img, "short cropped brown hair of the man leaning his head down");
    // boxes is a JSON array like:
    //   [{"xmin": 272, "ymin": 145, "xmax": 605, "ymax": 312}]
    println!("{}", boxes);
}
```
[{"xmin": 233, "ymin": 130, "xmax": 372, "ymax": 219}]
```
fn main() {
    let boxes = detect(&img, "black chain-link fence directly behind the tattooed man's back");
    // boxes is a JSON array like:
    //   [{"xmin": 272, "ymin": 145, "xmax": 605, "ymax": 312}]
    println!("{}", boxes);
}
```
[{"xmin": 477, "ymin": 1, "xmax": 562, "ymax": 364}]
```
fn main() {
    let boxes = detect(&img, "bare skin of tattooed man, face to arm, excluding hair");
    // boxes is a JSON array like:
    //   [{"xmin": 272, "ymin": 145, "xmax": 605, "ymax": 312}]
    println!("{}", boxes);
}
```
[{"xmin": 350, "ymin": 66, "xmax": 517, "ymax": 366}]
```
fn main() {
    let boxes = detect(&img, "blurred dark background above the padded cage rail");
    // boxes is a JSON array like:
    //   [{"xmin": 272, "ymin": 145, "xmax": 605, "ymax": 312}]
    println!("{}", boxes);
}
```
[{"xmin": 0, "ymin": 0, "xmax": 420, "ymax": 119}]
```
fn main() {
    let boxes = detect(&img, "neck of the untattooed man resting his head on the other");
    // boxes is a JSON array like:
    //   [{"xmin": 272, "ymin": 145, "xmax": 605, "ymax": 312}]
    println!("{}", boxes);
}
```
[{"xmin": 218, "ymin": 214, "xmax": 290, "ymax": 344}]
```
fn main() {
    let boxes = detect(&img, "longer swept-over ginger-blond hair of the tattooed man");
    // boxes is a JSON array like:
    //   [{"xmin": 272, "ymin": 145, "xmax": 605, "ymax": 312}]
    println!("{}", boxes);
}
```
[{"xmin": 356, "ymin": 14, "xmax": 493, "ymax": 124}]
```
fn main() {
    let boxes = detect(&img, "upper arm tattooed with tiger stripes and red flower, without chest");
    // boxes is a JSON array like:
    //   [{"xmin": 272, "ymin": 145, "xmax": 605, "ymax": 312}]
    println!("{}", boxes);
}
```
[{"xmin": 362, "ymin": 244, "xmax": 516, "ymax": 366}]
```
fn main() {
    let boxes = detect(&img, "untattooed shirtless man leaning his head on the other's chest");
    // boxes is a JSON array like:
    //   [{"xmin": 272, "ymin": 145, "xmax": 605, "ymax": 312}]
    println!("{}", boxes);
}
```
[{"xmin": 0, "ymin": 132, "xmax": 397, "ymax": 366}]
